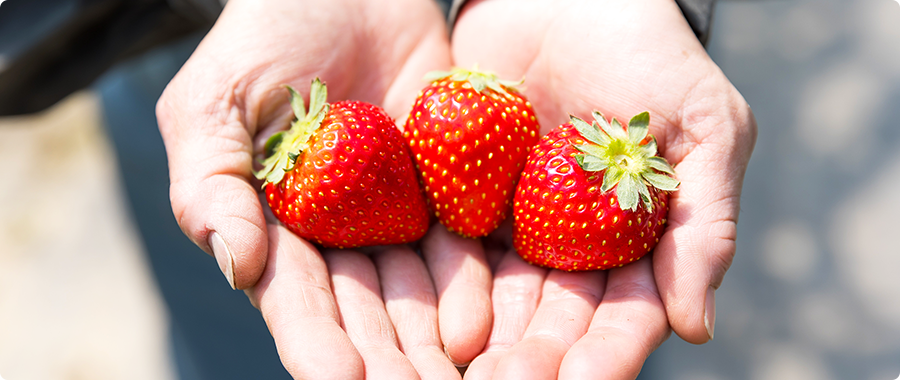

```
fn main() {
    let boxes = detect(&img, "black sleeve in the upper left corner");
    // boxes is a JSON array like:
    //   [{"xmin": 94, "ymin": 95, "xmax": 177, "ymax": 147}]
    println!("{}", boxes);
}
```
[{"xmin": 0, "ymin": 0, "xmax": 222, "ymax": 116}]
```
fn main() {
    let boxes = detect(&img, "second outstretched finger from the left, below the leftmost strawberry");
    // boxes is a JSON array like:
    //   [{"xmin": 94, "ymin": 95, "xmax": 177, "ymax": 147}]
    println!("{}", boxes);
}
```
[{"xmin": 323, "ymin": 251, "xmax": 419, "ymax": 380}]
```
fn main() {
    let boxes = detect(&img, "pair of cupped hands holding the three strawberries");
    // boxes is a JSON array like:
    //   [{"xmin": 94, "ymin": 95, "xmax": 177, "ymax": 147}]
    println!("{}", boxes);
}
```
[{"xmin": 157, "ymin": 0, "xmax": 756, "ymax": 379}]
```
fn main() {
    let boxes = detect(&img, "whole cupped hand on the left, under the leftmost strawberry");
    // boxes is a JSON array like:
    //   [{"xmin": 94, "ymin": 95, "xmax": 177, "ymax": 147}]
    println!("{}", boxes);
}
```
[{"xmin": 157, "ymin": 0, "xmax": 465, "ymax": 378}]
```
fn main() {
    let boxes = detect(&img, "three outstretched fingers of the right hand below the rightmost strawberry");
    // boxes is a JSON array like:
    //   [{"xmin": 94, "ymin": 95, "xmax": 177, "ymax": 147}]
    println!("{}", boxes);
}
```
[{"xmin": 465, "ymin": 223, "xmax": 670, "ymax": 380}]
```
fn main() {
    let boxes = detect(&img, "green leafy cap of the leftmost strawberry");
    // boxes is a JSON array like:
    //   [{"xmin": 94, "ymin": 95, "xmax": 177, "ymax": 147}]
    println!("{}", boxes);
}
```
[{"xmin": 253, "ymin": 78, "xmax": 329, "ymax": 186}]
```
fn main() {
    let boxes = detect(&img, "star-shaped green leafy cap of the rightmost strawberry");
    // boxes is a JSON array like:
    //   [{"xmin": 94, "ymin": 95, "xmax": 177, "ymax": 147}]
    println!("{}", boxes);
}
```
[{"xmin": 570, "ymin": 111, "xmax": 680, "ymax": 211}]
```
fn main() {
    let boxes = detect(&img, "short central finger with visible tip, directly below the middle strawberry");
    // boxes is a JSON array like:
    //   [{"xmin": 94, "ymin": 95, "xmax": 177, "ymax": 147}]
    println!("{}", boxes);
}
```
[{"xmin": 422, "ymin": 224, "xmax": 491, "ymax": 365}]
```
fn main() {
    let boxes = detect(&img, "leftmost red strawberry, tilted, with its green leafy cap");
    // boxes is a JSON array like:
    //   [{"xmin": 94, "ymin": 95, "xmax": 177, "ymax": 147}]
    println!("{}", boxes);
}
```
[{"xmin": 256, "ymin": 78, "xmax": 429, "ymax": 248}]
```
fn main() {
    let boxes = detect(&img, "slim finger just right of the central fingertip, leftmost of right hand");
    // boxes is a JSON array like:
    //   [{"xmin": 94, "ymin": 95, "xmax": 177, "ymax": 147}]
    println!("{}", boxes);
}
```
[{"xmin": 466, "ymin": 250, "xmax": 547, "ymax": 380}]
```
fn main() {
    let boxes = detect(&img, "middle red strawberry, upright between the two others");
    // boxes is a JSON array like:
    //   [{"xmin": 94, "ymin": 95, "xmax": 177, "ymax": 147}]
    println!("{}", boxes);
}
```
[{"xmin": 404, "ymin": 69, "xmax": 540, "ymax": 237}]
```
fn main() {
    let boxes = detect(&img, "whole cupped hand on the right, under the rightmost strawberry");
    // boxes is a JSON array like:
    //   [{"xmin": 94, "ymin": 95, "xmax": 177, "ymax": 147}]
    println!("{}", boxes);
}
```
[{"xmin": 445, "ymin": 0, "xmax": 756, "ymax": 378}]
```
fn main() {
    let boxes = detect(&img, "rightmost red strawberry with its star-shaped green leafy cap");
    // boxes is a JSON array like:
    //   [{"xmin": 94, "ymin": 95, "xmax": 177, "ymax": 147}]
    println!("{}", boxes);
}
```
[{"xmin": 513, "ymin": 112, "xmax": 679, "ymax": 271}]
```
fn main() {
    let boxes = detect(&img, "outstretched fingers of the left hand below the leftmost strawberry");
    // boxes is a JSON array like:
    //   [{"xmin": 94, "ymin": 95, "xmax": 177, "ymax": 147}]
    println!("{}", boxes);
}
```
[{"xmin": 246, "ymin": 225, "xmax": 460, "ymax": 379}]
